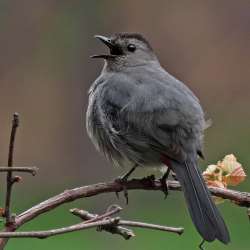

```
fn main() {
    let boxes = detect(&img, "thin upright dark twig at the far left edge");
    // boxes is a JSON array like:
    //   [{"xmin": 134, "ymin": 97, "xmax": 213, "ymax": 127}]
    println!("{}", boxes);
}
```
[{"xmin": 4, "ymin": 113, "xmax": 19, "ymax": 226}]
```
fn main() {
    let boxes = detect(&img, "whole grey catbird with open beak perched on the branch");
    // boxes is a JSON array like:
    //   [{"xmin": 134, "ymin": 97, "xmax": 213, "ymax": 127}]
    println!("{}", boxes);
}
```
[{"xmin": 87, "ymin": 33, "xmax": 230, "ymax": 243}]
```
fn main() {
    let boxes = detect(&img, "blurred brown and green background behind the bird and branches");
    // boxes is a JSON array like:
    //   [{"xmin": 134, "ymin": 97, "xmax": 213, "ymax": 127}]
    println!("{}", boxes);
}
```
[{"xmin": 0, "ymin": 0, "xmax": 250, "ymax": 250}]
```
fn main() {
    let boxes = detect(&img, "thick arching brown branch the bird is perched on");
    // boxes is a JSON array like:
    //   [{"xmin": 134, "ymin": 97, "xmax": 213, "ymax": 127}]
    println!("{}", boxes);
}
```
[{"xmin": 0, "ymin": 178, "xmax": 247, "ymax": 249}]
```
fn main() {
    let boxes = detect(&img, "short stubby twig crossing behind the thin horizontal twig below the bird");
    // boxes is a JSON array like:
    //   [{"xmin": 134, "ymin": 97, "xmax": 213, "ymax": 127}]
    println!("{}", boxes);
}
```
[{"xmin": 70, "ymin": 208, "xmax": 135, "ymax": 240}]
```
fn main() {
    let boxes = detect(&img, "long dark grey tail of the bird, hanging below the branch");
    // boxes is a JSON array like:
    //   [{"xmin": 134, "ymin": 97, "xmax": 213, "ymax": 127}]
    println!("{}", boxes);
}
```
[{"xmin": 171, "ymin": 156, "xmax": 230, "ymax": 244}]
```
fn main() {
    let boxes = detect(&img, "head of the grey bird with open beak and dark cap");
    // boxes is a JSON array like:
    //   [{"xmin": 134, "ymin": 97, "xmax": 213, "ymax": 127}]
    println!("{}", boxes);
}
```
[{"xmin": 92, "ymin": 33, "xmax": 157, "ymax": 67}]
